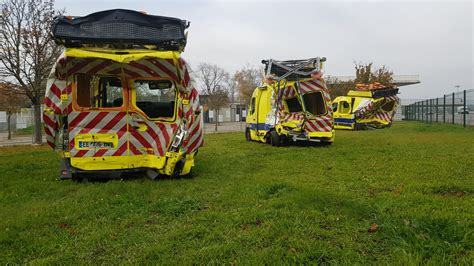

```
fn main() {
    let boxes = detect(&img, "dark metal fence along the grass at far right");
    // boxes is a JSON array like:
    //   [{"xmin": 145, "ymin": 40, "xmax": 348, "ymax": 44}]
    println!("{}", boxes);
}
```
[{"xmin": 403, "ymin": 90, "xmax": 474, "ymax": 126}]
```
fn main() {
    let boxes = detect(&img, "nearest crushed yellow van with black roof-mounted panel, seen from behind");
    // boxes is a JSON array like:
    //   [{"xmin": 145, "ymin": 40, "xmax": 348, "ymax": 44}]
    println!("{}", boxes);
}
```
[{"xmin": 43, "ymin": 9, "xmax": 203, "ymax": 178}]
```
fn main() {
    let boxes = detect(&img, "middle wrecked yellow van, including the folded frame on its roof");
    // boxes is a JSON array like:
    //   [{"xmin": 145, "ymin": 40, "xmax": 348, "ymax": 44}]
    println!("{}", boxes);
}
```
[{"xmin": 245, "ymin": 57, "xmax": 335, "ymax": 147}]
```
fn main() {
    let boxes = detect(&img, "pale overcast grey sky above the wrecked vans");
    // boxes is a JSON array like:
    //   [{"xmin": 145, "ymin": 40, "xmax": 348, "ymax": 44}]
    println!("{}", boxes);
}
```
[{"xmin": 56, "ymin": 0, "xmax": 474, "ymax": 99}]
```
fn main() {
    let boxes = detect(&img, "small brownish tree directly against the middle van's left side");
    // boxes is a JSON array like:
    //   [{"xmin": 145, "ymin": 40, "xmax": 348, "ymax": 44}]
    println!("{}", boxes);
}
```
[{"xmin": 233, "ymin": 66, "xmax": 262, "ymax": 103}]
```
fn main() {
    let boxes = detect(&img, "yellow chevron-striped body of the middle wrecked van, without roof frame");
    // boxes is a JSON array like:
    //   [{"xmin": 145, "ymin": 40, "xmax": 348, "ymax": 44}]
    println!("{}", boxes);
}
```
[{"xmin": 246, "ymin": 78, "xmax": 335, "ymax": 146}]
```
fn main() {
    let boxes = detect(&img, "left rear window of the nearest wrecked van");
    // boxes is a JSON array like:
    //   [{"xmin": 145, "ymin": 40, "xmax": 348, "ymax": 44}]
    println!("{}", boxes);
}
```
[{"xmin": 75, "ymin": 74, "xmax": 123, "ymax": 108}]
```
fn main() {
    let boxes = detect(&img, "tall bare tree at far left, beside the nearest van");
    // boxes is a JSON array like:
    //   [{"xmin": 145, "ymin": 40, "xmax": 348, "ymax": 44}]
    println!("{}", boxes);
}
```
[{"xmin": 0, "ymin": 0, "xmax": 62, "ymax": 143}]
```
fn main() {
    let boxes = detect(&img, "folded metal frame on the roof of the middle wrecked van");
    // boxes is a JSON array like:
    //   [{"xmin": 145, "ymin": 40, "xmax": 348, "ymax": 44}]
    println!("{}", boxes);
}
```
[{"xmin": 262, "ymin": 57, "xmax": 326, "ymax": 80}]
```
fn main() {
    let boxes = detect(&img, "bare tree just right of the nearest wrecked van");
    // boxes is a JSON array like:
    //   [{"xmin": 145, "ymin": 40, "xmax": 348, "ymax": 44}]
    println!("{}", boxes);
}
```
[{"xmin": 195, "ymin": 63, "xmax": 229, "ymax": 131}]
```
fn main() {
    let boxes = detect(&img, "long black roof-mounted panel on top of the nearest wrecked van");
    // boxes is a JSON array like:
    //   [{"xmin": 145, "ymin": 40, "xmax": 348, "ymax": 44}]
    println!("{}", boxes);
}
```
[{"xmin": 51, "ymin": 9, "xmax": 189, "ymax": 51}]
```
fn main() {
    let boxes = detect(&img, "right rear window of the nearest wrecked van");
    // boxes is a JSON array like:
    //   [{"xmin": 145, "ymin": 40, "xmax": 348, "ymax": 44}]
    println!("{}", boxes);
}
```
[{"xmin": 133, "ymin": 80, "xmax": 176, "ymax": 118}]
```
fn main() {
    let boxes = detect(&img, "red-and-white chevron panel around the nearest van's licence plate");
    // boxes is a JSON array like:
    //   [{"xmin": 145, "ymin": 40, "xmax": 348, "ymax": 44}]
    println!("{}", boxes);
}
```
[{"xmin": 68, "ymin": 111, "xmax": 128, "ymax": 157}]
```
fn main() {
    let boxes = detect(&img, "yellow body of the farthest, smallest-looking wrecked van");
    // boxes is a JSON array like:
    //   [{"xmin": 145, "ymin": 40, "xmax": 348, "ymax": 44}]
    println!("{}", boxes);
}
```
[{"xmin": 332, "ymin": 90, "xmax": 398, "ymax": 130}]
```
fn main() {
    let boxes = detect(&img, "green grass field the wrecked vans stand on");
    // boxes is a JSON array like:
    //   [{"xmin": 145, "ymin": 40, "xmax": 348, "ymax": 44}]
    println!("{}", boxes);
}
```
[{"xmin": 0, "ymin": 122, "xmax": 474, "ymax": 265}]
